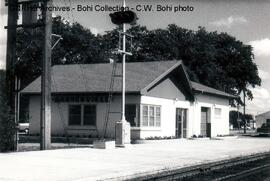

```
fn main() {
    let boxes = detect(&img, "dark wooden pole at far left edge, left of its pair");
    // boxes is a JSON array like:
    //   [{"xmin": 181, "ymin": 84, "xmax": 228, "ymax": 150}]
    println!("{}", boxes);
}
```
[{"xmin": 6, "ymin": 0, "xmax": 18, "ymax": 150}]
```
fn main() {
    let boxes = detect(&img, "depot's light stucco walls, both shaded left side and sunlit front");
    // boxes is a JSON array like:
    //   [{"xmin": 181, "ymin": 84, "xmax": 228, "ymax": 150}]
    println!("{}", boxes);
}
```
[{"xmin": 29, "ymin": 95, "xmax": 229, "ymax": 138}]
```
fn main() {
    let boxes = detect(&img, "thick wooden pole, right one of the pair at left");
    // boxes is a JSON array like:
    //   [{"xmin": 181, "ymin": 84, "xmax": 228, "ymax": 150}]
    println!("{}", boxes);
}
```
[{"xmin": 40, "ymin": 0, "xmax": 52, "ymax": 150}]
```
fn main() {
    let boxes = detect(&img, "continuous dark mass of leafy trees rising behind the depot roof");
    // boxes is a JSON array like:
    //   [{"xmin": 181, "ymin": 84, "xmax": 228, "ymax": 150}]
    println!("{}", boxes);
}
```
[{"xmin": 15, "ymin": 17, "xmax": 261, "ymax": 104}]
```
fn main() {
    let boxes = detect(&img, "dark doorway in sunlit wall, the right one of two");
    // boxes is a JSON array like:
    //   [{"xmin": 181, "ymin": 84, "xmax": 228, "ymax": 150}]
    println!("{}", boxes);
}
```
[{"xmin": 201, "ymin": 107, "xmax": 211, "ymax": 137}]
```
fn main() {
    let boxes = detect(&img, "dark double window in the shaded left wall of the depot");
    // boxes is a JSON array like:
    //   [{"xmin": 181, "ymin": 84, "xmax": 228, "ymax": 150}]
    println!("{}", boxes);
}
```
[{"xmin": 68, "ymin": 105, "xmax": 96, "ymax": 126}]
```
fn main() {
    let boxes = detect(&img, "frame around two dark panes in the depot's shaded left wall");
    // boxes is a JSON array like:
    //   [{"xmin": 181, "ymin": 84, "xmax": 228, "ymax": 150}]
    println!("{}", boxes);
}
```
[{"xmin": 68, "ymin": 103, "xmax": 97, "ymax": 127}]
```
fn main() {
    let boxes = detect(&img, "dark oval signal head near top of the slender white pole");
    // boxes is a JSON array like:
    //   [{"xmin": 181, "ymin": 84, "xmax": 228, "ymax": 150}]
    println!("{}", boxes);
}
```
[{"xmin": 110, "ymin": 11, "xmax": 137, "ymax": 25}]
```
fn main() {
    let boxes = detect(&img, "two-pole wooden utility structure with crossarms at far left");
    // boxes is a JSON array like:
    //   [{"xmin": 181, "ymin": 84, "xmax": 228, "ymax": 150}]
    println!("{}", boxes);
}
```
[{"xmin": 6, "ymin": 0, "xmax": 52, "ymax": 150}]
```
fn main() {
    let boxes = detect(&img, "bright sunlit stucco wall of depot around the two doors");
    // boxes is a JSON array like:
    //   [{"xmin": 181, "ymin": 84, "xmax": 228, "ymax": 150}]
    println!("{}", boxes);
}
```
[{"xmin": 137, "ymin": 95, "xmax": 229, "ymax": 138}]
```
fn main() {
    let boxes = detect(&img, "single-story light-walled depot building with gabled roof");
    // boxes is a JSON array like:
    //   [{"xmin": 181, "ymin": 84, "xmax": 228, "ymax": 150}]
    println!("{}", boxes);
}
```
[{"xmin": 21, "ymin": 61, "xmax": 235, "ymax": 138}]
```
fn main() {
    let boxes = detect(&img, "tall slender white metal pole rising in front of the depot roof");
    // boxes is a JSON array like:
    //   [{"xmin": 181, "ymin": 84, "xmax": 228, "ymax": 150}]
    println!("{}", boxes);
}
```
[{"xmin": 121, "ymin": 0, "xmax": 126, "ymax": 122}]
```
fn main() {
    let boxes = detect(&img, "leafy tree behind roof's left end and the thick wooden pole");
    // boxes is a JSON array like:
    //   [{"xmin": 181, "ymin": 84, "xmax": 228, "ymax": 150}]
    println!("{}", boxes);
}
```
[{"xmin": 16, "ymin": 16, "xmax": 105, "ymax": 87}]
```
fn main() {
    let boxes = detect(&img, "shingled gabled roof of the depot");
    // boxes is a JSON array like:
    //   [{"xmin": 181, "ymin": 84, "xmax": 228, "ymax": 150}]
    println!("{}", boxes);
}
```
[{"xmin": 21, "ymin": 60, "xmax": 236, "ymax": 97}]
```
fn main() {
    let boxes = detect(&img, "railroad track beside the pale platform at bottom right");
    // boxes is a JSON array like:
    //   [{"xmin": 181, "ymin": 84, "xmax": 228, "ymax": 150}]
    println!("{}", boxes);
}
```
[{"xmin": 123, "ymin": 152, "xmax": 270, "ymax": 181}]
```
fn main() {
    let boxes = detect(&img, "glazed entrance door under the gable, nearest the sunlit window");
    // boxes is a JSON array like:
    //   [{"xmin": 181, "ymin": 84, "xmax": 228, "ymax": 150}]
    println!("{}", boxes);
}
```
[{"xmin": 175, "ymin": 108, "xmax": 187, "ymax": 138}]
